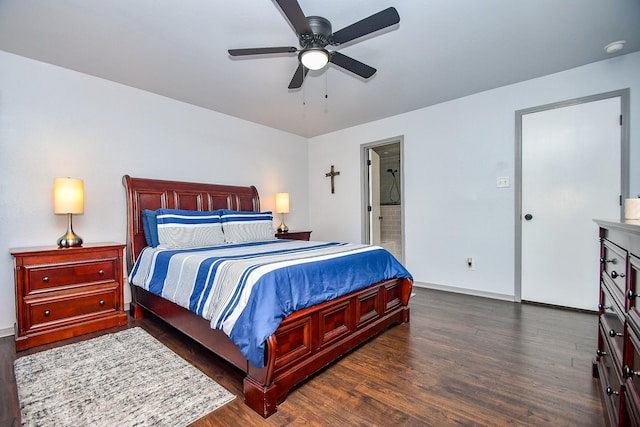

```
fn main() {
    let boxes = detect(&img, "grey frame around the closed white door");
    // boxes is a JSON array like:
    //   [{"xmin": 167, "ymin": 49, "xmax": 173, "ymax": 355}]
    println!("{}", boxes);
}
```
[{"xmin": 514, "ymin": 88, "xmax": 630, "ymax": 302}]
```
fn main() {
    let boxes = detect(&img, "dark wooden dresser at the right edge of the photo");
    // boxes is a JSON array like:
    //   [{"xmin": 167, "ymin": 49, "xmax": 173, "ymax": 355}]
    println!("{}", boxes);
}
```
[{"xmin": 593, "ymin": 220, "xmax": 640, "ymax": 426}]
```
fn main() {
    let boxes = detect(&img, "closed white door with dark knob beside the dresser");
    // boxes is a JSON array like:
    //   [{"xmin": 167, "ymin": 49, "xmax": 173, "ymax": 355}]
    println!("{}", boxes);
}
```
[{"xmin": 521, "ymin": 97, "xmax": 621, "ymax": 310}]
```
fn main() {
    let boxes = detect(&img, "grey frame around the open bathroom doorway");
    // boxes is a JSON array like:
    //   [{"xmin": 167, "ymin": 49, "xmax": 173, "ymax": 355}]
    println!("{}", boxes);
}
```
[{"xmin": 360, "ymin": 136, "xmax": 406, "ymax": 262}]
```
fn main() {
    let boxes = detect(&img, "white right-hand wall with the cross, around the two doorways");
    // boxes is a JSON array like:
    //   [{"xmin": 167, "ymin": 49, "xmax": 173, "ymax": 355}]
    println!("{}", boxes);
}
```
[{"xmin": 309, "ymin": 53, "xmax": 640, "ymax": 299}]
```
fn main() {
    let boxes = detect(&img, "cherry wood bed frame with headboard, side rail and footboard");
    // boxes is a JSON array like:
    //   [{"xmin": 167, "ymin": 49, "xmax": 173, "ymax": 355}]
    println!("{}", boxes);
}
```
[{"xmin": 123, "ymin": 175, "xmax": 412, "ymax": 418}]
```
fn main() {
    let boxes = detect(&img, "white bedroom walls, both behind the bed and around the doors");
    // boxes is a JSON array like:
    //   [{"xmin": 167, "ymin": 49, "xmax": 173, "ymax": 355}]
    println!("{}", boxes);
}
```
[{"xmin": 0, "ymin": 52, "xmax": 640, "ymax": 335}]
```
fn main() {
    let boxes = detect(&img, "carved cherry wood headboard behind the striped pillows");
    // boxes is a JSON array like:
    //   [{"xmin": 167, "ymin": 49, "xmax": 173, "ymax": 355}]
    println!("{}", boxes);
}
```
[{"xmin": 122, "ymin": 175, "xmax": 260, "ymax": 271}]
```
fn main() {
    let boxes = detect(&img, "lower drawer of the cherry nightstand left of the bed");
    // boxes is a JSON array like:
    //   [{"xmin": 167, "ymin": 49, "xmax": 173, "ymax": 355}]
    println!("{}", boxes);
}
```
[{"xmin": 25, "ymin": 286, "xmax": 118, "ymax": 329}]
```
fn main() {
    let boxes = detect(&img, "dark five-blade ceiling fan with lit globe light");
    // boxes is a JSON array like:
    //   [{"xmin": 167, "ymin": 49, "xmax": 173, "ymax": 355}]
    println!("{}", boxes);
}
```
[{"xmin": 229, "ymin": 0, "xmax": 400, "ymax": 89}]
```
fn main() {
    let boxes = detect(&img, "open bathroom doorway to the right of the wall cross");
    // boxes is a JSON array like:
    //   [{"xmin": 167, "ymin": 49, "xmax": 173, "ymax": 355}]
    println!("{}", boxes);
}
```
[{"xmin": 363, "ymin": 138, "xmax": 404, "ymax": 262}]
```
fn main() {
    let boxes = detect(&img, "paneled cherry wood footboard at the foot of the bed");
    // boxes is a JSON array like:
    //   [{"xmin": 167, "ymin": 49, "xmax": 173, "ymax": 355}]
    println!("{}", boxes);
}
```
[{"xmin": 244, "ymin": 279, "xmax": 411, "ymax": 417}]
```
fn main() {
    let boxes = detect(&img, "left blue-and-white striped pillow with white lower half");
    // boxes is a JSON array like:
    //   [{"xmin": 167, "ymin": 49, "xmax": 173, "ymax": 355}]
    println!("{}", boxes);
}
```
[{"xmin": 156, "ymin": 209, "xmax": 224, "ymax": 248}]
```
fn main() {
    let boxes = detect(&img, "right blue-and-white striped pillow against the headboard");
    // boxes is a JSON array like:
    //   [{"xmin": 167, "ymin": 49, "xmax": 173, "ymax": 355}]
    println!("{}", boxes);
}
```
[{"xmin": 220, "ymin": 209, "xmax": 275, "ymax": 243}]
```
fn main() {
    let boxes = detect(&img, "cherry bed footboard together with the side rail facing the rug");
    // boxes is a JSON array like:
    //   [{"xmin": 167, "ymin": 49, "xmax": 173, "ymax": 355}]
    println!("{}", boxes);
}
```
[{"xmin": 132, "ymin": 279, "xmax": 412, "ymax": 417}]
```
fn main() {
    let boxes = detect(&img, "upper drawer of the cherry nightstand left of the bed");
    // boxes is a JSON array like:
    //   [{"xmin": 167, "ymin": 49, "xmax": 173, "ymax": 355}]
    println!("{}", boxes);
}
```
[{"xmin": 26, "ymin": 259, "xmax": 117, "ymax": 295}]
